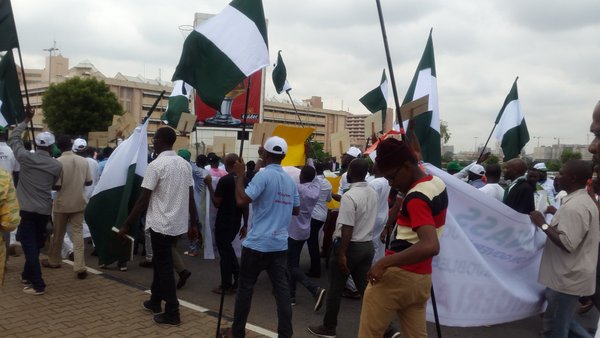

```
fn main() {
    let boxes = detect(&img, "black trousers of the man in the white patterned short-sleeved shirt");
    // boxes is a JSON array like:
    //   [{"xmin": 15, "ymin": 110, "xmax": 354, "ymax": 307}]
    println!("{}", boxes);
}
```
[{"xmin": 149, "ymin": 229, "xmax": 179, "ymax": 319}]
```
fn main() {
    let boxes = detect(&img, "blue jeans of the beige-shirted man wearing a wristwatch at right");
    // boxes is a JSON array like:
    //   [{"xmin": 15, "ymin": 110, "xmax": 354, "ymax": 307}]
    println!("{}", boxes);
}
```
[{"xmin": 543, "ymin": 288, "xmax": 592, "ymax": 338}]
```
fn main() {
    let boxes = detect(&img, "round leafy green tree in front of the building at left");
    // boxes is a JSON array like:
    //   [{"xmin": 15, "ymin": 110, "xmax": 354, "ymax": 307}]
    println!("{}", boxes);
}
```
[{"xmin": 42, "ymin": 77, "xmax": 123, "ymax": 135}]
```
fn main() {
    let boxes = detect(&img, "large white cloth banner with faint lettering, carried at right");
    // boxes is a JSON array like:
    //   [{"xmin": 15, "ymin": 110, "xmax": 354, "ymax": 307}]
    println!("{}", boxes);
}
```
[{"xmin": 426, "ymin": 164, "xmax": 546, "ymax": 327}]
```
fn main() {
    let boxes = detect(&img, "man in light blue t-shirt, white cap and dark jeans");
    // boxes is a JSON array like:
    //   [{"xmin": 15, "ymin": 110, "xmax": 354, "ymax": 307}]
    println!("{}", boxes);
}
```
[{"xmin": 222, "ymin": 136, "xmax": 300, "ymax": 338}]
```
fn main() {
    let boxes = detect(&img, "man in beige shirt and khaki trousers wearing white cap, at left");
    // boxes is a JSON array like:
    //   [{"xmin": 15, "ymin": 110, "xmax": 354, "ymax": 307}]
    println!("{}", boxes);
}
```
[{"xmin": 42, "ymin": 135, "xmax": 92, "ymax": 279}]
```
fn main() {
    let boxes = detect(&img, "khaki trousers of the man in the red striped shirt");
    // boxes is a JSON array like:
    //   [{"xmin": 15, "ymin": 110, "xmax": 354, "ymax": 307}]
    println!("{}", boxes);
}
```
[{"xmin": 358, "ymin": 267, "xmax": 431, "ymax": 338}]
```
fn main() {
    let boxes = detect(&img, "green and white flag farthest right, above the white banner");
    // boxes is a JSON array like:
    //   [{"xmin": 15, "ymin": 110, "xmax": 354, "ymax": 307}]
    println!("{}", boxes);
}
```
[{"xmin": 496, "ymin": 80, "xmax": 529, "ymax": 161}]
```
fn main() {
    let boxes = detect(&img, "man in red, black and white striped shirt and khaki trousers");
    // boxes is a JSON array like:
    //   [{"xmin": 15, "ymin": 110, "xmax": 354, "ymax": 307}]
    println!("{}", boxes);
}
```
[{"xmin": 358, "ymin": 138, "xmax": 448, "ymax": 338}]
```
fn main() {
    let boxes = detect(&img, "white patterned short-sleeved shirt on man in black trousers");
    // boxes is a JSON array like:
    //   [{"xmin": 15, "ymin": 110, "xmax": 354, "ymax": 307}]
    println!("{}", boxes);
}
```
[{"xmin": 142, "ymin": 150, "xmax": 194, "ymax": 236}]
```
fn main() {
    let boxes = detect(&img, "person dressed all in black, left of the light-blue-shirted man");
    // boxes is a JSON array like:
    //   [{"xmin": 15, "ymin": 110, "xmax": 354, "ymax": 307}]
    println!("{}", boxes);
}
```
[{"xmin": 206, "ymin": 154, "xmax": 248, "ymax": 294}]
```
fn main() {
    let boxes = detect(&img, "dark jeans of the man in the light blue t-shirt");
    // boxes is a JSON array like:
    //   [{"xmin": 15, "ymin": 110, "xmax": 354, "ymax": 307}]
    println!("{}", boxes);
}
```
[{"xmin": 231, "ymin": 247, "xmax": 293, "ymax": 338}]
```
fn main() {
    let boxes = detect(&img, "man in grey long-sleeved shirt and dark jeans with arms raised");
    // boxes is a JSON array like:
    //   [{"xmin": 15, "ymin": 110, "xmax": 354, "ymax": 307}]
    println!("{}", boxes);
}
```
[{"xmin": 8, "ymin": 111, "xmax": 62, "ymax": 295}]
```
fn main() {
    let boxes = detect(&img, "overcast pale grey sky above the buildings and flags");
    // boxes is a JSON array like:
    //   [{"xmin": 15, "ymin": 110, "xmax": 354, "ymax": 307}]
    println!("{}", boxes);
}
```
[{"xmin": 12, "ymin": 0, "xmax": 600, "ymax": 151}]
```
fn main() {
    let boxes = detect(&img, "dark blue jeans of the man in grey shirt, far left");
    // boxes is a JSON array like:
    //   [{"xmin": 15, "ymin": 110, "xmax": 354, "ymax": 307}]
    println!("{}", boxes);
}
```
[{"xmin": 16, "ymin": 210, "xmax": 50, "ymax": 291}]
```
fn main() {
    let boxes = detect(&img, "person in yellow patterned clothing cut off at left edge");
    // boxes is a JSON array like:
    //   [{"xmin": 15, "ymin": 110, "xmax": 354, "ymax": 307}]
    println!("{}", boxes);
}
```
[{"xmin": 0, "ymin": 169, "xmax": 21, "ymax": 286}]
